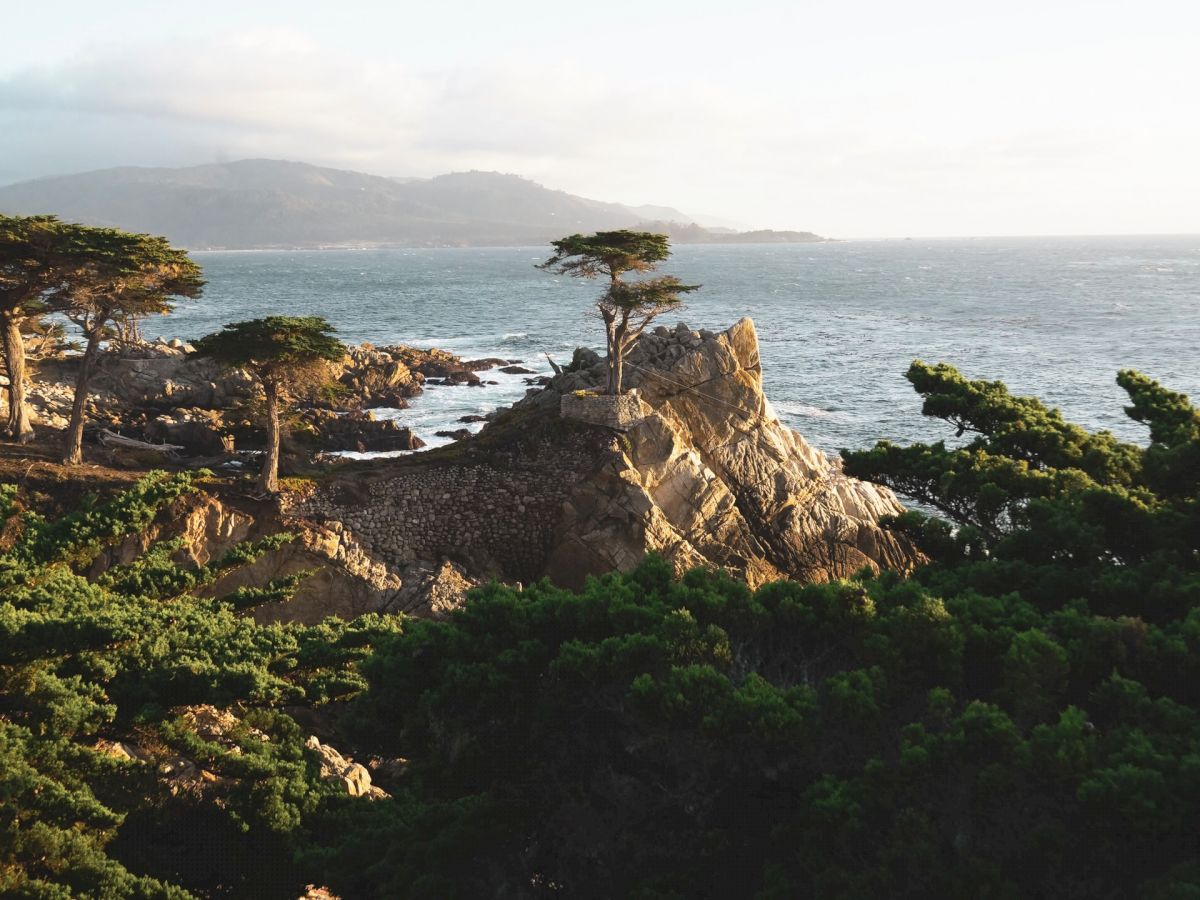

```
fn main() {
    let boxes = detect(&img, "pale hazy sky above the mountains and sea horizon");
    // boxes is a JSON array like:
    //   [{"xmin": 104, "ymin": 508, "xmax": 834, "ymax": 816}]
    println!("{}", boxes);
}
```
[{"xmin": 0, "ymin": 0, "xmax": 1200, "ymax": 236}]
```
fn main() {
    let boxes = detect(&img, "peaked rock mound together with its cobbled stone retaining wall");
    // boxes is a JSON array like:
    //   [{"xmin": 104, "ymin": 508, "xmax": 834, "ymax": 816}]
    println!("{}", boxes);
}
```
[{"xmin": 289, "ymin": 319, "xmax": 916, "ymax": 600}]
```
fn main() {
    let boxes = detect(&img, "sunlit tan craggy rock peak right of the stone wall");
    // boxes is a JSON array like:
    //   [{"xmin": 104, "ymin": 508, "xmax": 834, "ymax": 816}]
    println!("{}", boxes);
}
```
[{"xmin": 544, "ymin": 319, "xmax": 914, "ymax": 586}]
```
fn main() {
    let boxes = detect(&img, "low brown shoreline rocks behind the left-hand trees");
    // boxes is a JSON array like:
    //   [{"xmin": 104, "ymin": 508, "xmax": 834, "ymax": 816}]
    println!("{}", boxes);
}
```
[{"xmin": 29, "ymin": 338, "xmax": 544, "ymax": 468}]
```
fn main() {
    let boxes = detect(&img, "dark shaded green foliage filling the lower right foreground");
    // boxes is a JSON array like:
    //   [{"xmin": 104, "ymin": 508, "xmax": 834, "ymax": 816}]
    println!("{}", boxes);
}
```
[{"xmin": 324, "ymin": 364, "xmax": 1200, "ymax": 898}]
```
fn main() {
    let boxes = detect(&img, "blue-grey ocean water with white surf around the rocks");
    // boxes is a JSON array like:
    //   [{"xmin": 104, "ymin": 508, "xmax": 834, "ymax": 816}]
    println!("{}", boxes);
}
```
[{"xmin": 152, "ymin": 235, "xmax": 1200, "ymax": 452}]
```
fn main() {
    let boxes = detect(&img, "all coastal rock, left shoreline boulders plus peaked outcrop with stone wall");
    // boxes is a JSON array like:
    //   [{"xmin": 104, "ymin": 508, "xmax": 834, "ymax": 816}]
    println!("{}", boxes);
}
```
[{"xmin": 7, "ymin": 319, "xmax": 919, "ymax": 623}]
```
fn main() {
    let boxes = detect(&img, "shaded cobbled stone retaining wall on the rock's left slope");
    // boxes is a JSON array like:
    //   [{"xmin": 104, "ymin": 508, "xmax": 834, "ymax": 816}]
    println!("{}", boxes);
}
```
[{"xmin": 287, "ymin": 436, "xmax": 598, "ymax": 581}]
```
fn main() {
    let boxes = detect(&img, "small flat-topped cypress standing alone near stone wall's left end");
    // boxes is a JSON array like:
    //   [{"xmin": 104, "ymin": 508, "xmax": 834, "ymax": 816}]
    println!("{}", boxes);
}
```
[{"xmin": 196, "ymin": 316, "xmax": 346, "ymax": 493}]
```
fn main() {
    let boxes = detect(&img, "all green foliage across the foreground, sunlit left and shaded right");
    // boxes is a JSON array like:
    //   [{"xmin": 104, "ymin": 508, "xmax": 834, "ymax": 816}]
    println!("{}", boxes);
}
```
[{"xmin": 0, "ymin": 362, "xmax": 1200, "ymax": 898}]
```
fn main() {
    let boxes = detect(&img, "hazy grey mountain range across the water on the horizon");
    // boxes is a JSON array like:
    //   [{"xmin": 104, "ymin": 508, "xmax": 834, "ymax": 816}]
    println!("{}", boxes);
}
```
[{"xmin": 0, "ymin": 160, "xmax": 824, "ymax": 250}]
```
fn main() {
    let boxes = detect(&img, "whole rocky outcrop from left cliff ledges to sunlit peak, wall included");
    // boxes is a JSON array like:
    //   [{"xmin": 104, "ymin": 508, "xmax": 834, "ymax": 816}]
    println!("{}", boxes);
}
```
[{"xmin": 75, "ymin": 319, "xmax": 918, "ymax": 623}]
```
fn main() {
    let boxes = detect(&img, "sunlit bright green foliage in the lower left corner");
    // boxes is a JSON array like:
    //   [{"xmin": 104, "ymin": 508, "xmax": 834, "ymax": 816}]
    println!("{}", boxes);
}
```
[{"xmin": 0, "ymin": 473, "xmax": 398, "ymax": 898}]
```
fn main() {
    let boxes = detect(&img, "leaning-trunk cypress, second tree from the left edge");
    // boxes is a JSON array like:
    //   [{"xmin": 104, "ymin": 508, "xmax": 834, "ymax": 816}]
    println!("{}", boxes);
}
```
[{"xmin": 59, "ymin": 229, "xmax": 204, "ymax": 466}]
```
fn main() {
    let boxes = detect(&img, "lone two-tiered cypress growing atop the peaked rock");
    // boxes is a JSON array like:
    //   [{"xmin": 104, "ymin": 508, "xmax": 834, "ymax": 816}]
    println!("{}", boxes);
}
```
[{"xmin": 538, "ymin": 229, "xmax": 700, "ymax": 395}]
